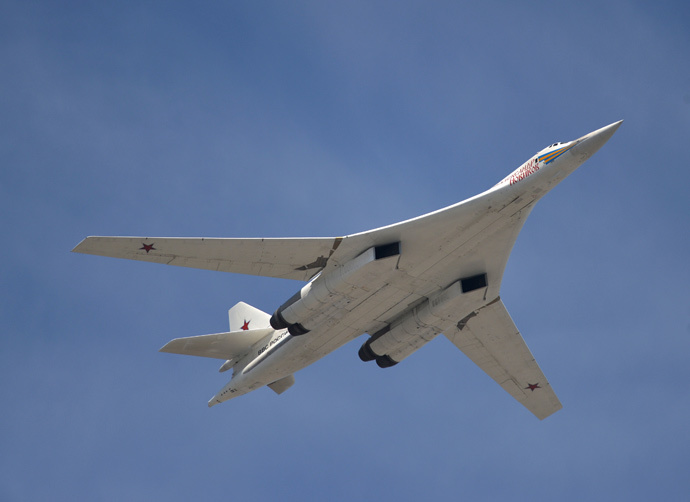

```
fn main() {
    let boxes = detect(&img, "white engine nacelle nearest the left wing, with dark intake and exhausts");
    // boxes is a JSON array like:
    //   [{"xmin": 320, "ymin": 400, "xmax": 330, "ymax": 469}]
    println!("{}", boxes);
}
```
[{"xmin": 271, "ymin": 242, "xmax": 400, "ymax": 335}]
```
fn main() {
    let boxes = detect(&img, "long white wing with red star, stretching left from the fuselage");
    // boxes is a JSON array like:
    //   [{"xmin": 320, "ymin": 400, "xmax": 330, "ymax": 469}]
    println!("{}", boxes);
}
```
[{"xmin": 72, "ymin": 236, "xmax": 342, "ymax": 281}]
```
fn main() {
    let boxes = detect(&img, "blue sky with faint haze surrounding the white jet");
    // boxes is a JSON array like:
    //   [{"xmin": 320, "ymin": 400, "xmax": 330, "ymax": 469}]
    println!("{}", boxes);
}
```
[{"xmin": 0, "ymin": 0, "xmax": 690, "ymax": 501}]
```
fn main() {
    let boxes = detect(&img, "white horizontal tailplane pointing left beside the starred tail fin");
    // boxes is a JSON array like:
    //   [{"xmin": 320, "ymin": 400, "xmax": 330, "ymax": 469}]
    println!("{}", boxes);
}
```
[{"xmin": 159, "ymin": 328, "xmax": 273, "ymax": 360}]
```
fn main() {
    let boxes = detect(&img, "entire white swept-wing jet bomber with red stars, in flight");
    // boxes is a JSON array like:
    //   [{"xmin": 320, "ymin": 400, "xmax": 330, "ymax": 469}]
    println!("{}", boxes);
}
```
[{"xmin": 73, "ymin": 121, "xmax": 622, "ymax": 419}]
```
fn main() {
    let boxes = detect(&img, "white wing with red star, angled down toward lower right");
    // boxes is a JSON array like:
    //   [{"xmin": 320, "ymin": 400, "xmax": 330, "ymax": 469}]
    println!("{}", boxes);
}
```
[{"xmin": 444, "ymin": 298, "xmax": 562, "ymax": 420}]
